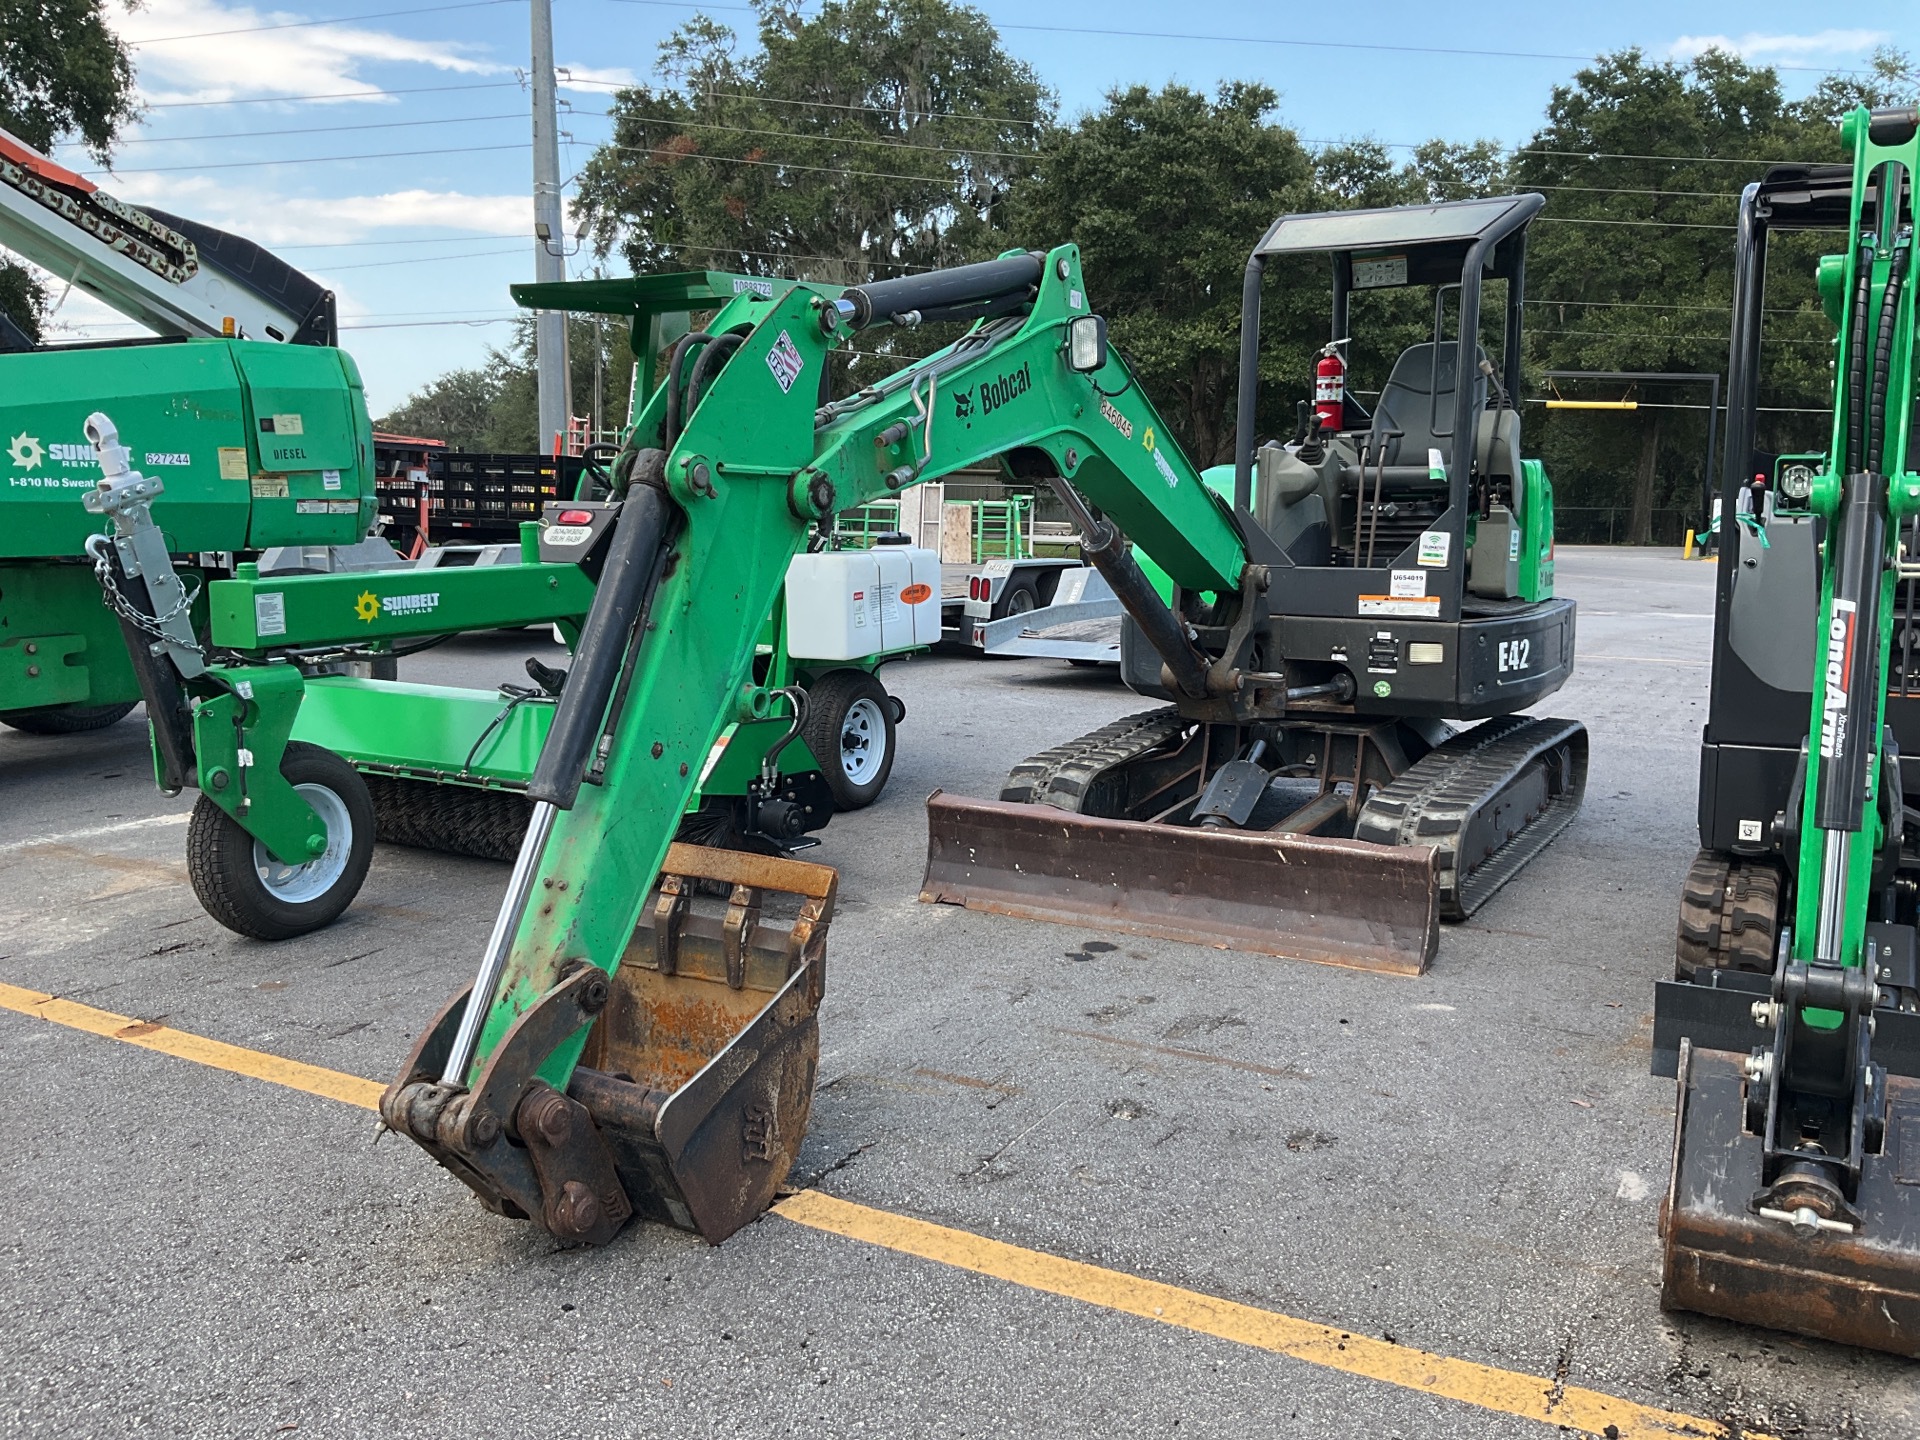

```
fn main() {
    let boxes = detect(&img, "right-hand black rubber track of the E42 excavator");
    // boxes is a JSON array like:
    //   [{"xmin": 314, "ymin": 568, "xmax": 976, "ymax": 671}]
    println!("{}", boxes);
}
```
[{"xmin": 1354, "ymin": 714, "xmax": 1586, "ymax": 920}]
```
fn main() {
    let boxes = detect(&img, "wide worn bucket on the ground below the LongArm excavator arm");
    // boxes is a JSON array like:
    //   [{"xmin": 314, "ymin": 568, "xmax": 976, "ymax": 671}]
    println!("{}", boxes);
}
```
[{"xmin": 1661, "ymin": 1041, "xmax": 1920, "ymax": 1357}]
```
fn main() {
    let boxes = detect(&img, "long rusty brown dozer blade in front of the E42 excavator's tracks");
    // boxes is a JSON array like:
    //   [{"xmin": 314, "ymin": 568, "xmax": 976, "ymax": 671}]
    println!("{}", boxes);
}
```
[{"xmin": 920, "ymin": 791, "xmax": 1440, "ymax": 975}]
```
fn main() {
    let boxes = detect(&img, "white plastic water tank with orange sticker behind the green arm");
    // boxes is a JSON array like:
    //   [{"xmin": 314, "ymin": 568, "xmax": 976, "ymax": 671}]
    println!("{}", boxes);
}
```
[{"xmin": 787, "ymin": 545, "xmax": 941, "ymax": 660}]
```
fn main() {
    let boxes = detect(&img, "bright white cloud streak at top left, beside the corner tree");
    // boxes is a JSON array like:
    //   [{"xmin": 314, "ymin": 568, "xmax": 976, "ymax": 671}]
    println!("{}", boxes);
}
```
[{"xmin": 108, "ymin": 0, "xmax": 511, "ymax": 104}]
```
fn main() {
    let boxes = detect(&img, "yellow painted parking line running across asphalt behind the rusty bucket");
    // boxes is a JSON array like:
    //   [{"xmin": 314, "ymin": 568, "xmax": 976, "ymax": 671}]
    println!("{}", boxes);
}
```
[{"xmin": 0, "ymin": 983, "xmax": 1776, "ymax": 1440}]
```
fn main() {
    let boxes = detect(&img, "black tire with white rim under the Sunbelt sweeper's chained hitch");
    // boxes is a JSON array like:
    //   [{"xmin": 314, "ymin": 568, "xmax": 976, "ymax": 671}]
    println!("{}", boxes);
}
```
[{"xmin": 186, "ymin": 739, "xmax": 374, "ymax": 941}]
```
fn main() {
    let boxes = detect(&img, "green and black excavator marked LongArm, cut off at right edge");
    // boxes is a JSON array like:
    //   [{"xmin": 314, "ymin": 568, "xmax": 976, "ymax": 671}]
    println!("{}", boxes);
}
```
[{"xmin": 1653, "ymin": 108, "xmax": 1920, "ymax": 1356}]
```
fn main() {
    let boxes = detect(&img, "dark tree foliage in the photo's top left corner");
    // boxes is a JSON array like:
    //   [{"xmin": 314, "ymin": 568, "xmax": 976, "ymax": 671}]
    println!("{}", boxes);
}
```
[{"xmin": 0, "ymin": 0, "xmax": 138, "ymax": 163}]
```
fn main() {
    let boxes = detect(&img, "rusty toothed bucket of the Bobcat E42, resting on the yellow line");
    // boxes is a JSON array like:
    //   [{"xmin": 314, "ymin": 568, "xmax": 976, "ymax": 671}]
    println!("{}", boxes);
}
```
[{"xmin": 380, "ymin": 845, "xmax": 837, "ymax": 1244}]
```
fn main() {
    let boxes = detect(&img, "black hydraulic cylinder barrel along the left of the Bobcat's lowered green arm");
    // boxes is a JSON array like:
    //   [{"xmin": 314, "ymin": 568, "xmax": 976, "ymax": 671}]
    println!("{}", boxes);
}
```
[{"xmin": 526, "ymin": 486, "xmax": 674, "ymax": 810}]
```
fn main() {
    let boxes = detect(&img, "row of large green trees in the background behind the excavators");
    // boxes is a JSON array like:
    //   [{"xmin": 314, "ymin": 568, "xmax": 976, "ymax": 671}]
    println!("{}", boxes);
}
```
[{"xmin": 401, "ymin": 25, "xmax": 1920, "ymax": 541}]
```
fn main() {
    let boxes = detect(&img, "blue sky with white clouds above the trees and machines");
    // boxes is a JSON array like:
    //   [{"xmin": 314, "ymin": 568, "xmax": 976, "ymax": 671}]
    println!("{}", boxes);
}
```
[{"xmin": 33, "ymin": 0, "xmax": 1901, "ymax": 415}]
